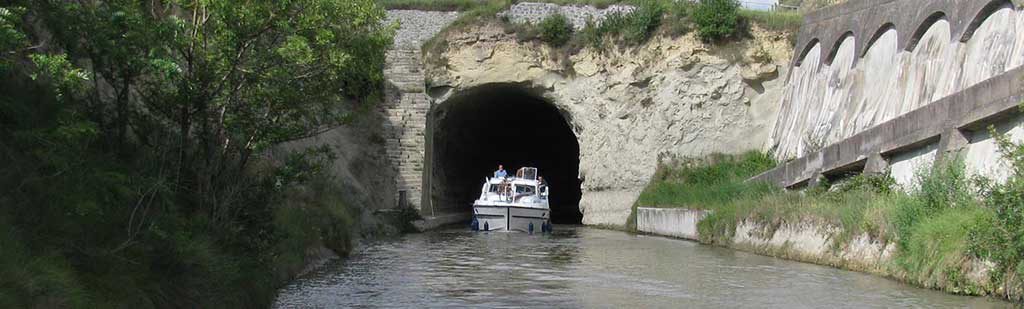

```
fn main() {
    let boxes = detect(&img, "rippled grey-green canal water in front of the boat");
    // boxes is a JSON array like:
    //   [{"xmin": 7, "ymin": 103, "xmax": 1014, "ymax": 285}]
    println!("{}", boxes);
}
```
[{"xmin": 274, "ymin": 226, "xmax": 1009, "ymax": 308}]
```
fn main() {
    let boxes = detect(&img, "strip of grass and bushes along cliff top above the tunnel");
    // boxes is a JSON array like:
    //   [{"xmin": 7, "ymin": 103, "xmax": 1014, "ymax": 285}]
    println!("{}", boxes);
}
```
[{"xmin": 419, "ymin": 0, "xmax": 803, "ymax": 68}]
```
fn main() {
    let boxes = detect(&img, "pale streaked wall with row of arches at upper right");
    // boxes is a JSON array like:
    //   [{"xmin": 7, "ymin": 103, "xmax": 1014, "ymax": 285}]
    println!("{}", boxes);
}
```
[{"xmin": 772, "ymin": 0, "xmax": 1024, "ymax": 159}]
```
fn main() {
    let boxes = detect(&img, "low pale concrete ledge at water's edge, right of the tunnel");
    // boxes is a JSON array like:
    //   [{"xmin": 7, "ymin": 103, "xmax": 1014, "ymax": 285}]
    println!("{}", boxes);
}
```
[{"xmin": 637, "ymin": 208, "xmax": 708, "ymax": 240}]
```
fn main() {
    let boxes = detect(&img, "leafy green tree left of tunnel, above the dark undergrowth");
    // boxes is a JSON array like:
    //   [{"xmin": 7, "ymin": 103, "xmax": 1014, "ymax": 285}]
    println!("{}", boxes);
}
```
[{"xmin": 31, "ymin": 0, "xmax": 390, "ymax": 220}]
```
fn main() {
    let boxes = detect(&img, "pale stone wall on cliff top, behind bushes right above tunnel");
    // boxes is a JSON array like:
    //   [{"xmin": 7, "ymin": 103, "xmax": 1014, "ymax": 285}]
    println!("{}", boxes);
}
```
[{"xmin": 498, "ymin": 2, "xmax": 636, "ymax": 30}]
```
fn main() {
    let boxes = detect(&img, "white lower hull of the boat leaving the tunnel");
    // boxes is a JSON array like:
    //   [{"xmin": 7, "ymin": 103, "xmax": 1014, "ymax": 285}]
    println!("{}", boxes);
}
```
[{"xmin": 473, "ymin": 205, "xmax": 551, "ymax": 232}]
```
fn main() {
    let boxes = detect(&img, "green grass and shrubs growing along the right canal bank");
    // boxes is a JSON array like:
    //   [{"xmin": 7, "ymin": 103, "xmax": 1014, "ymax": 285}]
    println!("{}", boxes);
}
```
[{"xmin": 630, "ymin": 124, "xmax": 1024, "ymax": 301}]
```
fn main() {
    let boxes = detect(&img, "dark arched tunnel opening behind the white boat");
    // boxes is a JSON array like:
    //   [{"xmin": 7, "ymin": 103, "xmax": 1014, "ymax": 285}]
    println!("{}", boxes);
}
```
[{"xmin": 427, "ymin": 85, "xmax": 583, "ymax": 224}]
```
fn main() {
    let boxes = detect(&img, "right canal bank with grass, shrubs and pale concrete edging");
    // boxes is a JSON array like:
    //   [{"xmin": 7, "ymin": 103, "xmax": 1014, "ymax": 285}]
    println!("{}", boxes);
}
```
[{"xmin": 627, "ymin": 150, "xmax": 1021, "ymax": 301}]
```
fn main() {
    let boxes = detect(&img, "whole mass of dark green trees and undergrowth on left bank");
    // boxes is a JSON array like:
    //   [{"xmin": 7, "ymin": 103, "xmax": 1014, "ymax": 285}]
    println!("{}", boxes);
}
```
[{"xmin": 0, "ymin": 0, "xmax": 391, "ymax": 308}]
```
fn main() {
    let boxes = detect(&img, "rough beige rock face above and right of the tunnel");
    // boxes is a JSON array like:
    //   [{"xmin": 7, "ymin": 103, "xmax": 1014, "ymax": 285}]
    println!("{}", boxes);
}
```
[{"xmin": 426, "ymin": 25, "xmax": 792, "ymax": 225}]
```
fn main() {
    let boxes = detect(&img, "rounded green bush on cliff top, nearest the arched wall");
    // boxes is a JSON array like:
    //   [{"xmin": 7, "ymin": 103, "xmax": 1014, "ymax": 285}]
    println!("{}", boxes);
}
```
[{"xmin": 692, "ymin": 0, "xmax": 739, "ymax": 42}]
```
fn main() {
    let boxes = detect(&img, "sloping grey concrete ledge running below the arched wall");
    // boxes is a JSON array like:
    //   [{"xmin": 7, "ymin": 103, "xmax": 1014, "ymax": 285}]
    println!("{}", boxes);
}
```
[{"xmin": 751, "ymin": 67, "xmax": 1024, "ymax": 187}]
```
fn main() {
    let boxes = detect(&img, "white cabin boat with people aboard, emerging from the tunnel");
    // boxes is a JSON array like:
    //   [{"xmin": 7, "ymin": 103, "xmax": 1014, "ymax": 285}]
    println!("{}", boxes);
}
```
[{"xmin": 471, "ymin": 168, "xmax": 551, "ymax": 233}]
